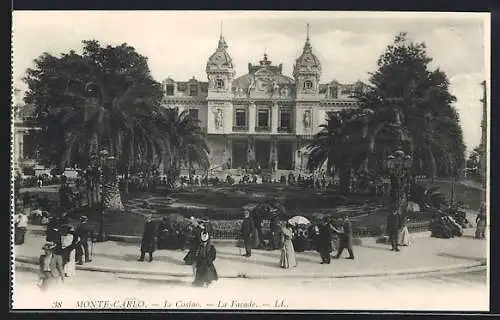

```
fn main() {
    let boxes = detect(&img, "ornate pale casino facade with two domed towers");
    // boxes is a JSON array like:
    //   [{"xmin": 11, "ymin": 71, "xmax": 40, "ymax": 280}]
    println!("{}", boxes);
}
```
[{"xmin": 163, "ymin": 32, "xmax": 366, "ymax": 175}]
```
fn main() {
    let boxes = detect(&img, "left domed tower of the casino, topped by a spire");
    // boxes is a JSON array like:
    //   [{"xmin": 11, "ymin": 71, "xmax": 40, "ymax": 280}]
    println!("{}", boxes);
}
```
[{"xmin": 206, "ymin": 34, "xmax": 235, "ymax": 99}]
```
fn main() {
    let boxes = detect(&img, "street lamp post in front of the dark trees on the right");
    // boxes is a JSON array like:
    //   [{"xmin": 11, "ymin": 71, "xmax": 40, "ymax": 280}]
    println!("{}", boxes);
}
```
[{"xmin": 386, "ymin": 150, "xmax": 413, "ymax": 204}]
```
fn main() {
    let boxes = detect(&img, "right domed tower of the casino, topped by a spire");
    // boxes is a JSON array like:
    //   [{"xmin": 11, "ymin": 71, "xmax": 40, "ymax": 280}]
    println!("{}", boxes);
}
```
[{"xmin": 293, "ymin": 24, "xmax": 321, "ymax": 100}]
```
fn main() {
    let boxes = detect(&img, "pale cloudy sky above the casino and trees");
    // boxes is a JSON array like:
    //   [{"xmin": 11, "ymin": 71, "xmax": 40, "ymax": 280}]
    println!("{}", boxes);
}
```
[{"xmin": 12, "ymin": 11, "xmax": 490, "ymax": 151}]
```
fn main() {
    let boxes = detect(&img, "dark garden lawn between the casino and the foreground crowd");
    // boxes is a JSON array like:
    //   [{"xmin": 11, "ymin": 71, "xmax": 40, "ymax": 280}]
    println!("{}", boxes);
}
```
[{"xmin": 26, "ymin": 181, "xmax": 481, "ymax": 235}]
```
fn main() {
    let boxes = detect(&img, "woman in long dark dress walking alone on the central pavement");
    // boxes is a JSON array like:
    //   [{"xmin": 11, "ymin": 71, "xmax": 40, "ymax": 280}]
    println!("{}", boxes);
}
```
[{"xmin": 193, "ymin": 231, "xmax": 219, "ymax": 287}]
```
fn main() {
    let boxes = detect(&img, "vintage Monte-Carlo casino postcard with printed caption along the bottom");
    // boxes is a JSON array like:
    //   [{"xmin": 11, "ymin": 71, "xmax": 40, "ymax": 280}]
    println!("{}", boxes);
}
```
[{"xmin": 11, "ymin": 11, "xmax": 490, "ymax": 312}]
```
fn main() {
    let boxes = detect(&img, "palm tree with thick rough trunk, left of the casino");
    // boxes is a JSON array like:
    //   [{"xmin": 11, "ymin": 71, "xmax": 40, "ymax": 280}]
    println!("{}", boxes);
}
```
[{"xmin": 57, "ymin": 82, "xmax": 165, "ymax": 210}]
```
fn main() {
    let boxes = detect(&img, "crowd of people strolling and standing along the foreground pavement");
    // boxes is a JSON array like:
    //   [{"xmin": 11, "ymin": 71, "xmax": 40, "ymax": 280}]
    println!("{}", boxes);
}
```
[{"xmin": 19, "ymin": 192, "xmax": 486, "ymax": 290}]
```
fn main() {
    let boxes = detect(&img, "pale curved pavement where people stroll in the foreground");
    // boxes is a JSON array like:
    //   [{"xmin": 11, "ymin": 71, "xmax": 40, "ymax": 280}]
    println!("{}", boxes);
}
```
[{"xmin": 15, "ymin": 224, "xmax": 487, "ymax": 278}]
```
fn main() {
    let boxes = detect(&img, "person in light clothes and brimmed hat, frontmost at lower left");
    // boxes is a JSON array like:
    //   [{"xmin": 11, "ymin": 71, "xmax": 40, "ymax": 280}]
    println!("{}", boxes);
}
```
[{"xmin": 38, "ymin": 242, "xmax": 64, "ymax": 291}]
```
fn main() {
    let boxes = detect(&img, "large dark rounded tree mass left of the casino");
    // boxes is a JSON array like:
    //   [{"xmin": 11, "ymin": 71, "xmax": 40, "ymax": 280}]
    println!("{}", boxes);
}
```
[{"xmin": 24, "ymin": 40, "xmax": 162, "ymax": 210}]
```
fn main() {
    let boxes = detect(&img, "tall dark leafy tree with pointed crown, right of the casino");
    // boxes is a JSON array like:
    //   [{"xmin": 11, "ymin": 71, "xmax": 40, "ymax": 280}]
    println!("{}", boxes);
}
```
[{"xmin": 355, "ymin": 33, "xmax": 465, "ymax": 176}]
